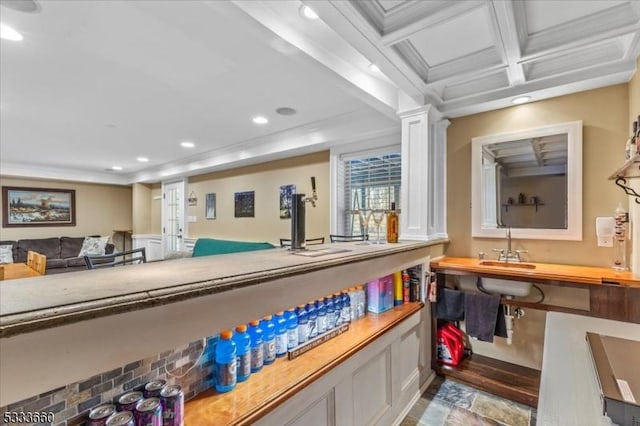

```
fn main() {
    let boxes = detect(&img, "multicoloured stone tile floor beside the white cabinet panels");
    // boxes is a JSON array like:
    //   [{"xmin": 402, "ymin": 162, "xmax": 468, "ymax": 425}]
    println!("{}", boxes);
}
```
[{"xmin": 400, "ymin": 377, "xmax": 536, "ymax": 426}]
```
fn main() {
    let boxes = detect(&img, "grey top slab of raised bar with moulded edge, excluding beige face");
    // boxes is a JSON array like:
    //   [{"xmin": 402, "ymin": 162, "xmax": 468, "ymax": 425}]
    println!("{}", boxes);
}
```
[{"xmin": 0, "ymin": 241, "xmax": 442, "ymax": 337}]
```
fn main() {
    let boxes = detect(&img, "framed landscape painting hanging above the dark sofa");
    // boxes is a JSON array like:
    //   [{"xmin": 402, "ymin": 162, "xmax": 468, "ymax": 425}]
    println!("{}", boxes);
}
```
[{"xmin": 2, "ymin": 186, "xmax": 76, "ymax": 228}]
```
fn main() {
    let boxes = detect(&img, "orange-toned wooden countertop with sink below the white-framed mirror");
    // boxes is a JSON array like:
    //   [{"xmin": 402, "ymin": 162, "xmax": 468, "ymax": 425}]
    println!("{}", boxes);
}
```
[{"xmin": 431, "ymin": 257, "xmax": 640, "ymax": 288}]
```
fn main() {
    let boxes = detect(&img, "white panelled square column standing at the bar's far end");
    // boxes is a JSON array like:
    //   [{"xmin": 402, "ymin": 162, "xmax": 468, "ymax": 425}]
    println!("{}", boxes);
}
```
[{"xmin": 399, "ymin": 105, "xmax": 449, "ymax": 241}]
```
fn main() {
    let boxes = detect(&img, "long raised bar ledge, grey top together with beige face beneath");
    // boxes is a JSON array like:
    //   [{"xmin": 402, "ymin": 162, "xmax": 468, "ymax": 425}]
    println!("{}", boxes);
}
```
[{"xmin": 0, "ymin": 240, "xmax": 444, "ymax": 406}]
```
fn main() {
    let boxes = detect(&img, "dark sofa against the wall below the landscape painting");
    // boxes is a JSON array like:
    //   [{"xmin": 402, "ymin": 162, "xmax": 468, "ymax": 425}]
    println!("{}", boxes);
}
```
[{"xmin": 0, "ymin": 237, "xmax": 115, "ymax": 275}]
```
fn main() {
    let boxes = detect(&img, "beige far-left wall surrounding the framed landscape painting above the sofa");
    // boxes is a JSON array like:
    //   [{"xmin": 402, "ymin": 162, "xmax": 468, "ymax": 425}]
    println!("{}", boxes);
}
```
[{"xmin": 0, "ymin": 176, "xmax": 132, "ymax": 246}]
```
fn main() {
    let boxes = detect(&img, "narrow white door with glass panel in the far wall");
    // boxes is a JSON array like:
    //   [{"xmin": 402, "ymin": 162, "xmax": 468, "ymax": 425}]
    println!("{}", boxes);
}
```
[{"xmin": 162, "ymin": 180, "xmax": 186, "ymax": 256}]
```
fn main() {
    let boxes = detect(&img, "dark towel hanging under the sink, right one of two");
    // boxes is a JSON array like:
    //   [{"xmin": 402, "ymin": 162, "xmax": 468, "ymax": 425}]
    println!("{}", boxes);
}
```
[{"xmin": 464, "ymin": 293, "xmax": 500, "ymax": 342}]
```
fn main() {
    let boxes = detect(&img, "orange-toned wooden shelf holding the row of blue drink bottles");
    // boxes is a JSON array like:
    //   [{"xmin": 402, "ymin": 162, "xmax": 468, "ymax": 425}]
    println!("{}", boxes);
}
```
[{"xmin": 184, "ymin": 303, "xmax": 423, "ymax": 426}]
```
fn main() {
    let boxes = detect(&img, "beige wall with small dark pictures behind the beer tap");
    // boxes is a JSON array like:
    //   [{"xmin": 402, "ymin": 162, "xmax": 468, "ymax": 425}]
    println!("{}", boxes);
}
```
[{"xmin": 187, "ymin": 151, "xmax": 329, "ymax": 243}]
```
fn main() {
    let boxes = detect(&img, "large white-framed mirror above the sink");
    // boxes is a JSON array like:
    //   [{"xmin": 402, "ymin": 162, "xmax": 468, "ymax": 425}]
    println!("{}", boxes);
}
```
[{"xmin": 471, "ymin": 121, "xmax": 582, "ymax": 240}]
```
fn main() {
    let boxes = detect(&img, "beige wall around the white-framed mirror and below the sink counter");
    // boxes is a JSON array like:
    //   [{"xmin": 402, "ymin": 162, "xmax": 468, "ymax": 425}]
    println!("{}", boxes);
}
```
[{"xmin": 446, "ymin": 83, "xmax": 640, "ymax": 369}]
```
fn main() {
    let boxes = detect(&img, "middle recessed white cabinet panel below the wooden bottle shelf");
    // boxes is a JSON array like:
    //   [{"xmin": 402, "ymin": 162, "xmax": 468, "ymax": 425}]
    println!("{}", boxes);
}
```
[{"xmin": 353, "ymin": 347, "xmax": 391, "ymax": 426}]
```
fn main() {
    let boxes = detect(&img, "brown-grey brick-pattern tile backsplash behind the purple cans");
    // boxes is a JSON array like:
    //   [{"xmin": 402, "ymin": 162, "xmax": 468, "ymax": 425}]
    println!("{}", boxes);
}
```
[{"xmin": 0, "ymin": 340, "xmax": 213, "ymax": 426}]
